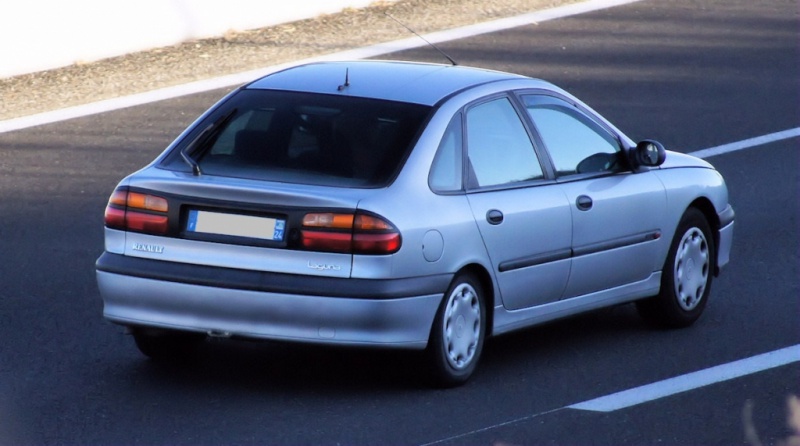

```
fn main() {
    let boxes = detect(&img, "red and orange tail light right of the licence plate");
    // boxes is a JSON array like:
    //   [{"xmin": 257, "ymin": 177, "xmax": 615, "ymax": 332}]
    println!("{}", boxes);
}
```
[{"xmin": 300, "ymin": 212, "xmax": 401, "ymax": 254}]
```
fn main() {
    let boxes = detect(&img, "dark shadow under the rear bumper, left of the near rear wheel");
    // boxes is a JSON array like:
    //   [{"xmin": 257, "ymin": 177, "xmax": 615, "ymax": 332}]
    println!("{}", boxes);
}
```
[{"xmin": 128, "ymin": 338, "xmax": 429, "ymax": 394}]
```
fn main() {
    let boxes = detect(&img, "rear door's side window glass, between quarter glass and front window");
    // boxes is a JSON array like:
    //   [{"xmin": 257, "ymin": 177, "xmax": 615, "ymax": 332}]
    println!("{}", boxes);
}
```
[{"xmin": 466, "ymin": 98, "xmax": 544, "ymax": 187}]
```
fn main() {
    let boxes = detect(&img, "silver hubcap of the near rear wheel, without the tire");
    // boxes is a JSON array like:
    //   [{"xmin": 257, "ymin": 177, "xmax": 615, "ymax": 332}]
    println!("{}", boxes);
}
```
[{"xmin": 444, "ymin": 283, "xmax": 481, "ymax": 369}]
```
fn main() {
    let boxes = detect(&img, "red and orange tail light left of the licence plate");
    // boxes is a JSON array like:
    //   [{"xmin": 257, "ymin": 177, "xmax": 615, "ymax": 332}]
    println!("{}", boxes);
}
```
[{"xmin": 105, "ymin": 189, "xmax": 169, "ymax": 235}]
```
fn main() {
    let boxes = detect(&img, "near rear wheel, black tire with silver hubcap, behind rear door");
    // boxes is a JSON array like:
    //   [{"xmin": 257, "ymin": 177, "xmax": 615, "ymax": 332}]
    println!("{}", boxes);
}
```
[{"xmin": 427, "ymin": 274, "xmax": 486, "ymax": 387}]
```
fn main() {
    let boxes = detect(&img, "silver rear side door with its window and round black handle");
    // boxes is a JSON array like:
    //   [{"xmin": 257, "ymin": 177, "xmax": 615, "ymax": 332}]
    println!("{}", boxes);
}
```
[{"xmin": 456, "ymin": 96, "xmax": 572, "ymax": 310}]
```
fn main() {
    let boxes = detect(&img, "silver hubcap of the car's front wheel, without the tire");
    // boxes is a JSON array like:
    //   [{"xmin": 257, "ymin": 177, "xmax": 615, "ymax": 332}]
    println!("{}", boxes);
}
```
[{"xmin": 673, "ymin": 228, "xmax": 711, "ymax": 311}]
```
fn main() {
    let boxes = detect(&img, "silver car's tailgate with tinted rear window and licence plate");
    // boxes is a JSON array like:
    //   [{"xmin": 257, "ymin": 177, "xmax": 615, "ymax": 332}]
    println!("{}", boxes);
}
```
[{"xmin": 139, "ymin": 88, "xmax": 438, "ymax": 277}]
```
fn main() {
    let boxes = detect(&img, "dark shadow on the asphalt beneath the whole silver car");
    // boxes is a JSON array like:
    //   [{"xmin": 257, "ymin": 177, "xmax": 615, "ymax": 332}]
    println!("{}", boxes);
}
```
[{"xmin": 123, "ymin": 305, "xmax": 650, "ymax": 395}]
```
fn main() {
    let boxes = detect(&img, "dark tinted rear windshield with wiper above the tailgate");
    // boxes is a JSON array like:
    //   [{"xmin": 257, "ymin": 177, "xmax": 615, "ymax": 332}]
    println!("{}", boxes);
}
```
[{"xmin": 161, "ymin": 90, "xmax": 430, "ymax": 187}]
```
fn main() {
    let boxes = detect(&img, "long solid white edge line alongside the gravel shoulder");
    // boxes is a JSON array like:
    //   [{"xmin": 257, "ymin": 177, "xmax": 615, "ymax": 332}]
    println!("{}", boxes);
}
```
[{"xmin": 0, "ymin": 0, "xmax": 641, "ymax": 133}]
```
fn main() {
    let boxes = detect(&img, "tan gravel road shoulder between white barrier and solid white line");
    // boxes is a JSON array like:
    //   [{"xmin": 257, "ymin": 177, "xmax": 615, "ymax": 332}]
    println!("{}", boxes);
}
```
[{"xmin": 0, "ymin": 0, "xmax": 575, "ymax": 120}]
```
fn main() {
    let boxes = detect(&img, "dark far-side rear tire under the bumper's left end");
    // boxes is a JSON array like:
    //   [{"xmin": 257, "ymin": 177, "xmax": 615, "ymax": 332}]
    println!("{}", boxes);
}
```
[{"xmin": 133, "ymin": 328, "xmax": 205, "ymax": 362}]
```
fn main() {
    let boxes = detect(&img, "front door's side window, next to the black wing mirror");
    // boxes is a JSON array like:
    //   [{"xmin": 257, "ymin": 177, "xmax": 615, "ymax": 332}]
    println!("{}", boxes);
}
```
[{"xmin": 523, "ymin": 95, "xmax": 622, "ymax": 176}]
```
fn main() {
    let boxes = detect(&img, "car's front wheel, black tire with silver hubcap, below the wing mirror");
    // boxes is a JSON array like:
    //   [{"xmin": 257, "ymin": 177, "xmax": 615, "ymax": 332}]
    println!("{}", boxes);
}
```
[{"xmin": 636, "ymin": 208, "xmax": 716, "ymax": 328}]
